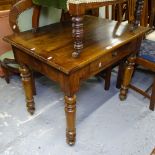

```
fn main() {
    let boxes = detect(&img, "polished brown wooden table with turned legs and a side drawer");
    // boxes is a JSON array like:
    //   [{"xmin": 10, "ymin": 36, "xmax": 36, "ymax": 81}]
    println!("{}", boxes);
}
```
[{"xmin": 5, "ymin": 16, "xmax": 146, "ymax": 145}]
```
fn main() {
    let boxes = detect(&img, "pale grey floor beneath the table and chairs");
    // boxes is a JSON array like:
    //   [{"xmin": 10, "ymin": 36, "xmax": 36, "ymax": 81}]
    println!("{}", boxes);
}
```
[{"xmin": 0, "ymin": 68, "xmax": 155, "ymax": 155}]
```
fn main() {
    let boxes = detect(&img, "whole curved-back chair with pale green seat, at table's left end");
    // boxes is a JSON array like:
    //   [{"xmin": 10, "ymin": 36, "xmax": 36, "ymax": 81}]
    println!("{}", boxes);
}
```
[{"xmin": 0, "ymin": 1, "xmax": 61, "ymax": 83}]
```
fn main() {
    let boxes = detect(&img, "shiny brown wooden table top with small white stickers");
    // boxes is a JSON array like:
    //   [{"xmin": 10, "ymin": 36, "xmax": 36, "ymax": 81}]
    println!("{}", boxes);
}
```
[{"xmin": 4, "ymin": 16, "xmax": 146, "ymax": 74}]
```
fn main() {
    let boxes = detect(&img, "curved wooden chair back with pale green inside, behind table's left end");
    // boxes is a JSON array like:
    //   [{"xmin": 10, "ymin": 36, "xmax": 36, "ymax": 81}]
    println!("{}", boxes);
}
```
[{"xmin": 9, "ymin": 0, "xmax": 61, "ymax": 32}]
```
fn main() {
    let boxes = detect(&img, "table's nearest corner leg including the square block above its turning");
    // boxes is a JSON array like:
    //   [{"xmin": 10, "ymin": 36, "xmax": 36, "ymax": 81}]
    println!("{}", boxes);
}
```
[{"xmin": 60, "ymin": 73, "xmax": 80, "ymax": 146}]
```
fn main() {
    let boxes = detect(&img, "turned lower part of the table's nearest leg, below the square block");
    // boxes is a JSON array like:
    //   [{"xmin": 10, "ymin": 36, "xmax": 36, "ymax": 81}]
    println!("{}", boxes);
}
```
[{"xmin": 65, "ymin": 95, "xmax": 76, "ymax": 145}]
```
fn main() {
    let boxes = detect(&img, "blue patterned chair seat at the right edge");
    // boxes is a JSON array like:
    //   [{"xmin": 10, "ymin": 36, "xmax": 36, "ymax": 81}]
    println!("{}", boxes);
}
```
[{"xmin": 139, "ymin": 39, "xmax": 155, "ymax": 62}]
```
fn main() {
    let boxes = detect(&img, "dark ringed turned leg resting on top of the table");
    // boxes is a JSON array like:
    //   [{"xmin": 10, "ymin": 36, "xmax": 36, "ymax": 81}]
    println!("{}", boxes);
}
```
[{"xmin": 72, "ymin": 16, "xmax": 83, "ymax": 58}]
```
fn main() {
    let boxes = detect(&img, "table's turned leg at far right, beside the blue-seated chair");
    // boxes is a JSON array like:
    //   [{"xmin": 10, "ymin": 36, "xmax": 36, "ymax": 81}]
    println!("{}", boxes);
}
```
[{"xmin": 119, "ymin": 57, "xmax": 135, "ymax": 101}]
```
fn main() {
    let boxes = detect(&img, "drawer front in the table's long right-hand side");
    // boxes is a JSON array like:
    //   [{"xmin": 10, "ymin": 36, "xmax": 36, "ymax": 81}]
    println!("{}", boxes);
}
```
[{"xmin": 90, "ymin": 42, "xmax": 136, "ymax": 74}]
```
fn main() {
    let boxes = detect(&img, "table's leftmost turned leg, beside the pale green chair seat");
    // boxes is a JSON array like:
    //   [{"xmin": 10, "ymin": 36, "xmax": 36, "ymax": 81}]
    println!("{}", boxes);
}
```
[{"xmin": 19, "ymin": 65, "xmax": 35, "ymax": 115}]
